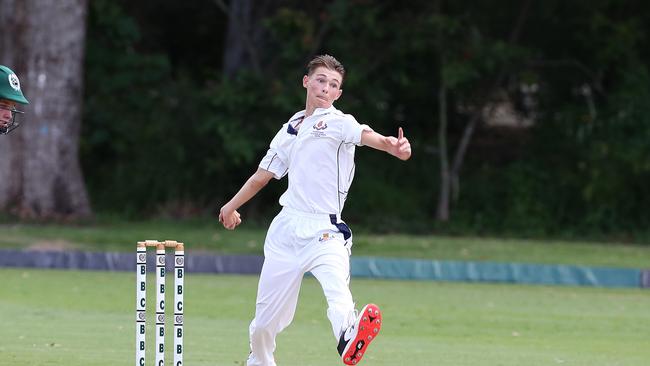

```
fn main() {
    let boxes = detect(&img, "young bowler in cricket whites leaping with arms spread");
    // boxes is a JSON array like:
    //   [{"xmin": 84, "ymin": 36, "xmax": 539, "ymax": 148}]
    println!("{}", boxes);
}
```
[{"xmin": 219, "ymin": 55, "xmax": 411, "ymax": 366}]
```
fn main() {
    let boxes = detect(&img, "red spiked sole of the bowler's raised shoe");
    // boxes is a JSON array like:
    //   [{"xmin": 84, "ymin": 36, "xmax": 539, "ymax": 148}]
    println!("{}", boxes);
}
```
[{"xmin": 341, "ymin": 304, "xmax": 382, "ymax": 365}]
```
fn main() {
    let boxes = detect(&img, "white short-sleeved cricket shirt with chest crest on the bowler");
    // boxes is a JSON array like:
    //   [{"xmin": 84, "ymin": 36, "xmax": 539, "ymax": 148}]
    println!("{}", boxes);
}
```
[{"xmin": 259, "ymin": 106, "xmax": 371, "ymax": 215}]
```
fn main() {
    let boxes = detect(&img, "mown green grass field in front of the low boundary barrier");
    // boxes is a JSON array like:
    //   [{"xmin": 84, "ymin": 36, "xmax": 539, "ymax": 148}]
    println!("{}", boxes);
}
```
[{"xmin": 0, "ymin": 269, "xmax": 650, "ymax": 366}]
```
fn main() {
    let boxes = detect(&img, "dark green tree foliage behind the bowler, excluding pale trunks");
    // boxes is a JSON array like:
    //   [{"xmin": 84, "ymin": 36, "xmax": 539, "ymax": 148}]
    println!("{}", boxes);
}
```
[{"xmin": 82, "ymin": 0, "xmax": 650, "ymax": 235}]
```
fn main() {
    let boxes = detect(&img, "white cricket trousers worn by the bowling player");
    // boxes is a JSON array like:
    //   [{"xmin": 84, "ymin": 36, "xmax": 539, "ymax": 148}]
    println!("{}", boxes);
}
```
[{"xmin": 247, "ymin": 207, "xmax": 355, "ymax": 366}]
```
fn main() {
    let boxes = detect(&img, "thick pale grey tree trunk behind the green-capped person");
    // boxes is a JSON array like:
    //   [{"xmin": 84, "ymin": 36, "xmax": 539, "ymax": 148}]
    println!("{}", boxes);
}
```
[{"xmin": 0, "ymin": 0, "xmax": 92, "ymax": 219}]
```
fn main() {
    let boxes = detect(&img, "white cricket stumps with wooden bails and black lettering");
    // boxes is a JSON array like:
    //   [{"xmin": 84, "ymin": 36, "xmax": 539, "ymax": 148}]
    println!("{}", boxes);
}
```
[{"xmin": 135, "ymin": 240, "xmax": 185, "ymax": 366}]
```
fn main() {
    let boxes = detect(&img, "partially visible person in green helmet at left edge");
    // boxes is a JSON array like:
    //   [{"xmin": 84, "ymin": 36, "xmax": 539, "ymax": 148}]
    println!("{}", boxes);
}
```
[{"xmin": 0, "ymin": 65, "xmax": 29, "ymax": 135}]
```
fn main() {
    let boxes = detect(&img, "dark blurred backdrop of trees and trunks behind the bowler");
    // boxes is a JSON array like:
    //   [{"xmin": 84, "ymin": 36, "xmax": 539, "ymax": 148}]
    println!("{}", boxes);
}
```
[{"xmin": 0, "ymin": 0, "xmax": 650, "ymax": 242}]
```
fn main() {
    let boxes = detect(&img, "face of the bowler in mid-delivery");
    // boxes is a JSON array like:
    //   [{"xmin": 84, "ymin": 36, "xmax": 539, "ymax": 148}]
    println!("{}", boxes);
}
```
[{"xmin": 302, "ymin": 66, "xmax": 343, "ymax": 108}]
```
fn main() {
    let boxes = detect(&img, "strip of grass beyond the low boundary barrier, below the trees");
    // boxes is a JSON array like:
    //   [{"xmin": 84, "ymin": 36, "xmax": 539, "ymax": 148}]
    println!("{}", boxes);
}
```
[{"xmin": 0, "ymin": 220, "xmax": 650, "ymax": 268}]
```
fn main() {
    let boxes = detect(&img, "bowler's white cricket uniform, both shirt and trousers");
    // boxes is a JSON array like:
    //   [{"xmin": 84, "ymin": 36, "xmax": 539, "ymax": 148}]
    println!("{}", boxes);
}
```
[{"xmin": 248, "ymin": 107, "xmax": 370, "ymax": 366}]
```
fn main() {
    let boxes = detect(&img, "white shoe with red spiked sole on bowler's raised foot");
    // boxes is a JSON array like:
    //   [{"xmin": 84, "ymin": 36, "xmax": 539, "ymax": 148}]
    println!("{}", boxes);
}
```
[{"xmin": 337, "ymin": 304, "xmax": 381, "ymax": 365}]
